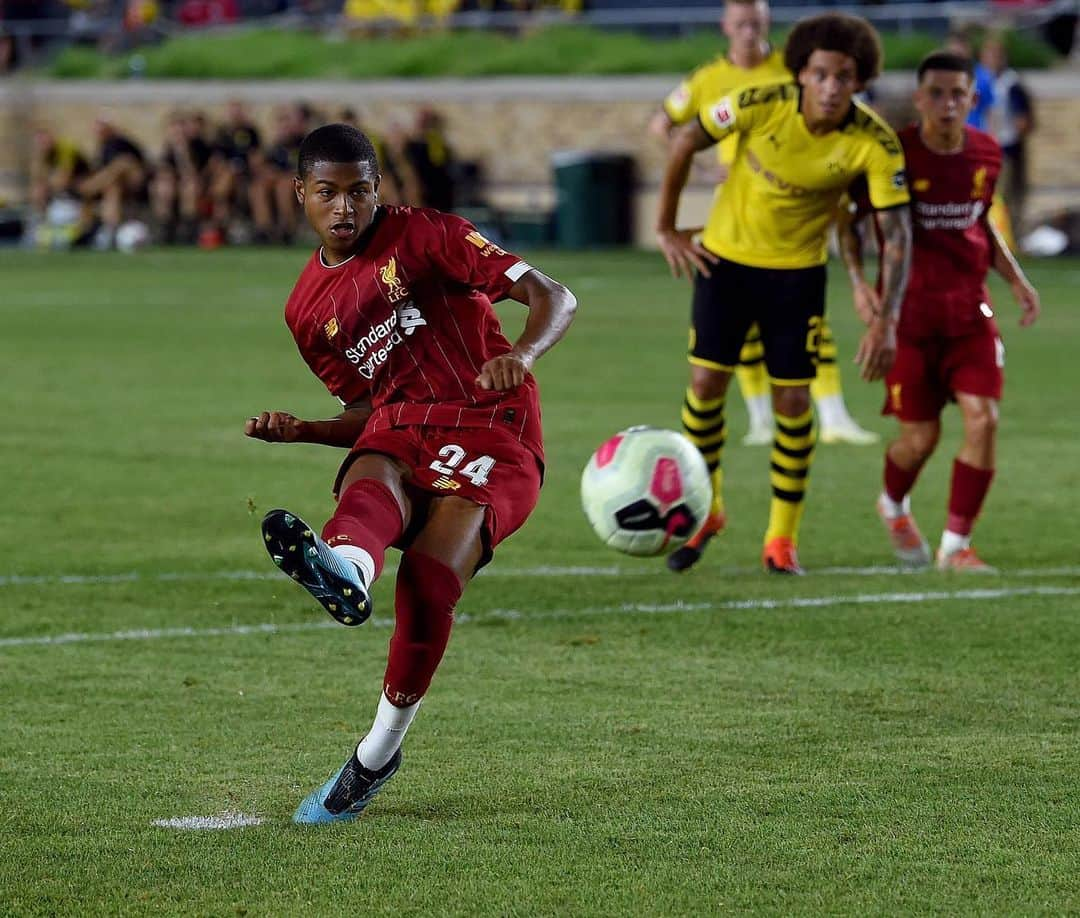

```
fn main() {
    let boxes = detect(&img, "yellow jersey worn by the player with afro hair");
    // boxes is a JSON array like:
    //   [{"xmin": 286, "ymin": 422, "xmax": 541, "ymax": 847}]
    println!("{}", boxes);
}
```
[{"xmin": 698, "ymin": 82, "xmax": 908, "ymax": 268}]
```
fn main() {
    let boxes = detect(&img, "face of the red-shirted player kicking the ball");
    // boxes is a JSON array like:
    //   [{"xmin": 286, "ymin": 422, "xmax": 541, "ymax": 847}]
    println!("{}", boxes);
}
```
[{"xmin": 296, "ymin": 162, "xmax": 381, "ymax": 260}]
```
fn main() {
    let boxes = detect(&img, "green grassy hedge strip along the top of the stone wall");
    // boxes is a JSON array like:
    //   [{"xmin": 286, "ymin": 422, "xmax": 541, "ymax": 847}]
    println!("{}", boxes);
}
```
[{"xmin": 45, "ymin": 26, "xmax": 1055, "ymax": 80}]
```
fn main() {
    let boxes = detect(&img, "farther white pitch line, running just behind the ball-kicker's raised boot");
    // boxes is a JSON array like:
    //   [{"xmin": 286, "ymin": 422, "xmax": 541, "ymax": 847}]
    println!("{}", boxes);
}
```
[{"xmin": 0, "ymin": 562, "xmax": 1080, "ymax": 586}]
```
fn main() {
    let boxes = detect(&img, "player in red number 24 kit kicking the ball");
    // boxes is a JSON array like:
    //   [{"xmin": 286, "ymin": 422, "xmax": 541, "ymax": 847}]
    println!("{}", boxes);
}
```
[{"xmin": 244, "ymin": 124, "xmax": 577, "ymax": 823}]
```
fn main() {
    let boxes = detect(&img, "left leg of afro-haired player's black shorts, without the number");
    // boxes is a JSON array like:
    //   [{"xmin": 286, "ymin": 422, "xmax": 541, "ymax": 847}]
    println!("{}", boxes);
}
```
[{"xmin": 688, "ymin": 258, "xmax": 758, "ymax": 373}]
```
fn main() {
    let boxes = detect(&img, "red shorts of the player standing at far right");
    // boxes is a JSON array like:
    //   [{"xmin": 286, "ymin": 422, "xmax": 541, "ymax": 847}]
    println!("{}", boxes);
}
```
[{"xmin": 881, "ymin": 323, "xmax": 1005, "ymax": 421}]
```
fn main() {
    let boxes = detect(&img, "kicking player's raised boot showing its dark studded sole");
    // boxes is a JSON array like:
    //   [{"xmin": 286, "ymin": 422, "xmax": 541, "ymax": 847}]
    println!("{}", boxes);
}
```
[{"xmin": 262, "ymin": 510, "xmax": 372, "ymax": 625}]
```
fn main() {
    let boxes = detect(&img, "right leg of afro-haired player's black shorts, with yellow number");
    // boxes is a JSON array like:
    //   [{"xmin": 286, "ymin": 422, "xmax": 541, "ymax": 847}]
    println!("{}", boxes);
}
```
[{"xmin": 755, "ymin": 265, "xmax": 825, "ymax": 386}]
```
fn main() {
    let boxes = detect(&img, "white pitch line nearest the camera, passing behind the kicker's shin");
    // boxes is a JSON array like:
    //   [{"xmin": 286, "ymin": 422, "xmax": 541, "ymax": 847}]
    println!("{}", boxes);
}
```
[{"xmin": 0, "ymin": 586, "xmax": 1080, "ymax": 648}]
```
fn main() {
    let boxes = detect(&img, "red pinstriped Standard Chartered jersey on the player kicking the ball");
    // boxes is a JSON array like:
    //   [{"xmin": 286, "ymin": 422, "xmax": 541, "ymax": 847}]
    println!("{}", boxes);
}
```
[{"xmin": 285, "ymin": 205, "xmax": 543, "ymax": 459}]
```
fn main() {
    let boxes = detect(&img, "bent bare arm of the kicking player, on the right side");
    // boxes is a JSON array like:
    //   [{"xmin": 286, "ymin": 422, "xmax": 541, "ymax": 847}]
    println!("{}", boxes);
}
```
[{"xmin": 476, "ymin": 268, "xmax": 578, "ymax": 390}]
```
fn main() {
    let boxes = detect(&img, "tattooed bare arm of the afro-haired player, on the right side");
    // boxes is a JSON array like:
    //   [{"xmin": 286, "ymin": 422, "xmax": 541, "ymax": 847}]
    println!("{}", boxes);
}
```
[{"xmin": 855, "ymin": 207, "xmax": 912, "ymax": 381}]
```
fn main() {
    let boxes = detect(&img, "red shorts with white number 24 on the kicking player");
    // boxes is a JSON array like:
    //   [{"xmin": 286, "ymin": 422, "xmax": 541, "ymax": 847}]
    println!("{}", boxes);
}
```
[{"xmin": 334, "ymin": 427, "xmax": 543, "ymax": 565}]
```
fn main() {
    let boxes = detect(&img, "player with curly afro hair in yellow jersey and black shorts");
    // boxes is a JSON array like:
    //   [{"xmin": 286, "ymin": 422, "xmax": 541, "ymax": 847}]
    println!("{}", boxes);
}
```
[{"xmin": 657, "ymin": 15, "xmax": 910, "ymax": 573}]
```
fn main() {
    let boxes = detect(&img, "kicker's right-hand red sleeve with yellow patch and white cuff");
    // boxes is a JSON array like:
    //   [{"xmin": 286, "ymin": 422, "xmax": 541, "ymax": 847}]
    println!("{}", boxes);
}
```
[{"xmin": 423, "ymin": 211, "xmax": 530, "ymax": 301}]
